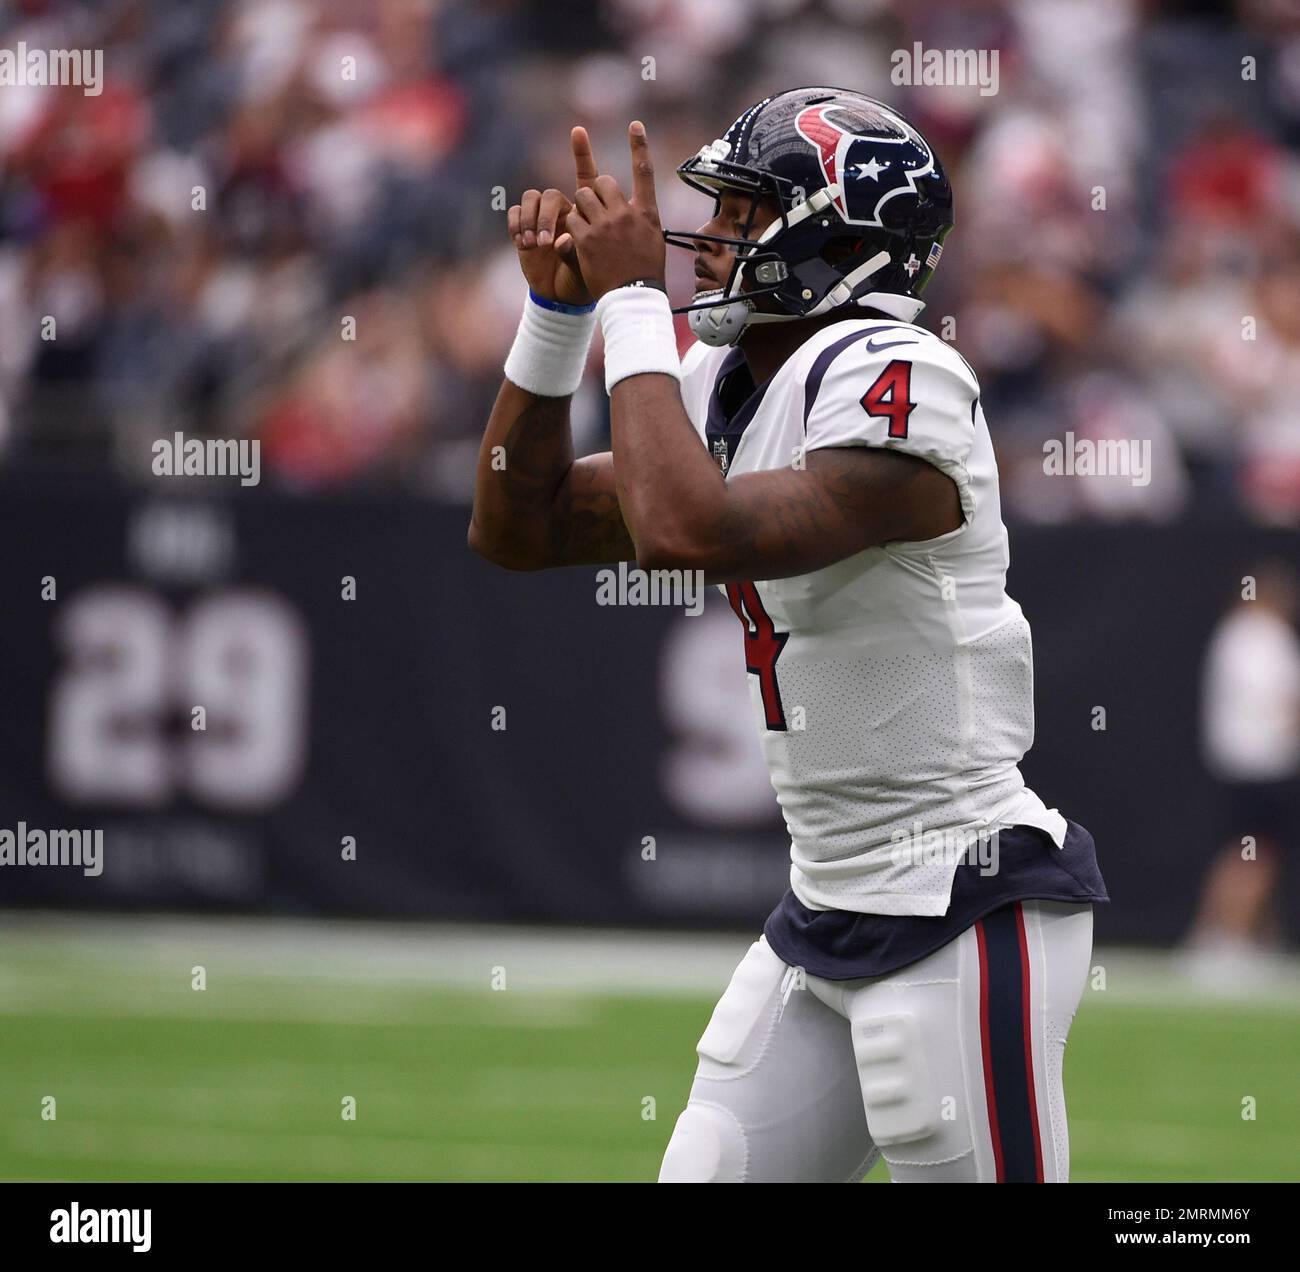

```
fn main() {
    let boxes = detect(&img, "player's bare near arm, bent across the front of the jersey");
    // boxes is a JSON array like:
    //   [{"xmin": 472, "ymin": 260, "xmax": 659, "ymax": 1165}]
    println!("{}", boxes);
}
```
[{"xmin": 611, "ymin": 375, "xmax": 962, "ymax": 583}]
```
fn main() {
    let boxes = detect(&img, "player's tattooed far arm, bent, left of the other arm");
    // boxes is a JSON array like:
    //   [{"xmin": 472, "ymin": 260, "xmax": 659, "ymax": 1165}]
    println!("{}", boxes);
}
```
[{"xmin": 469, "ymin": 380, "xmax": 636, "ymax": 570}]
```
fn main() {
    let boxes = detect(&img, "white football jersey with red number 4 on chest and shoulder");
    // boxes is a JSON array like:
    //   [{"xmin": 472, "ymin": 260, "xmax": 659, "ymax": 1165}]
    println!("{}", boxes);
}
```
[{"xmin": 681, "ymin": 317, "xmax": 1066, "ymax": 914}]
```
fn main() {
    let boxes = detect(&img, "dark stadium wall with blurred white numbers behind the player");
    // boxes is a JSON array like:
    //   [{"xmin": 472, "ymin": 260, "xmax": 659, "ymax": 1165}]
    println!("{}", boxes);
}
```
[{"xmin": 0, "ymin": 483, "xmax": 1300, "ymax": 943}]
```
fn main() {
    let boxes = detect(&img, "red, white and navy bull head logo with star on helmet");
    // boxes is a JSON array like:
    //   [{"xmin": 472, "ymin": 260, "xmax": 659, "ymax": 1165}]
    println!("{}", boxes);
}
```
[{"xmin": 794, "ymin": 104, "xmax": 935, "ymax": 225}]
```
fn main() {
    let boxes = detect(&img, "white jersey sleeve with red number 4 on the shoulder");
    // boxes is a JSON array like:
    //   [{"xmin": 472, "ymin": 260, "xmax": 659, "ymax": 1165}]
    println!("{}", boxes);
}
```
[{"xmin": 803, "ymin": 332, "xmax": 979, "ymax": 524}]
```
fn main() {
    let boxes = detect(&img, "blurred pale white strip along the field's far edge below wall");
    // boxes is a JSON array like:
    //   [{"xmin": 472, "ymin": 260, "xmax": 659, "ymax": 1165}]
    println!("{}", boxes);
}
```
[{"xmin": 0, "ymin": 910, "xmax": 1300, "ymax": 1014}]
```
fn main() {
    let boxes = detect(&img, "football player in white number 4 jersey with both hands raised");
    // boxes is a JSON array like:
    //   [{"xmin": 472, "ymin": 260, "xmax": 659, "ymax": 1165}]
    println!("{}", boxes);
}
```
[{"xmin": 469, "ymin": 87, "xmax": 1106, "ymax": 1182}]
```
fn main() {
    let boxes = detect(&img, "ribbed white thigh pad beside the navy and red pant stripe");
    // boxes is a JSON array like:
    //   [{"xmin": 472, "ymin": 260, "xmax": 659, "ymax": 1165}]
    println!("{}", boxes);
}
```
[{"xmin": 853, "ymin": 1013, "xmax": 940, "ymax": 1147}]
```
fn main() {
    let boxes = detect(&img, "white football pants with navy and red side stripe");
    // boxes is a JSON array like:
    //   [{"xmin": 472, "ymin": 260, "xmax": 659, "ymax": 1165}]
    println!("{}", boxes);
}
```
[{"xmin": 659, "ymin": 901, "xmax": 1092, "ymax": 1184}]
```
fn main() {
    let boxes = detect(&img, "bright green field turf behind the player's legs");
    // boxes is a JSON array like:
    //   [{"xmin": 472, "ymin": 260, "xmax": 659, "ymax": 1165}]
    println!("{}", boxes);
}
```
[{"xmin": 0, "ymin": 920, "xmax": 1300, "ymax": 1181}]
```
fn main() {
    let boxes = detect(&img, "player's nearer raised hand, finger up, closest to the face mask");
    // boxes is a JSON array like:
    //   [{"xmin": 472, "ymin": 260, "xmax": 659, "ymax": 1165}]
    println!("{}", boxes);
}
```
[{"xmin": 566, "ymin": 120, "xmax": 666, "ymax": 297}]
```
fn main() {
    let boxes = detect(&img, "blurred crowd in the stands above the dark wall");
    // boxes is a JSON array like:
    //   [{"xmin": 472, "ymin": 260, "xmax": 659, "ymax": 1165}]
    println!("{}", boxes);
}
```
[{"xmin": 0, "ymin": 0, "xmax": 1300, "ymax": 524}]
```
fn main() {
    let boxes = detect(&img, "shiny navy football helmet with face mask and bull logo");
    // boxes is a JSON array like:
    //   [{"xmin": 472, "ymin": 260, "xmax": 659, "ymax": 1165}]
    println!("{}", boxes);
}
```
[{"xmin": 664, "ymin": 88, "xmax": 953, "ymax": 345}]
